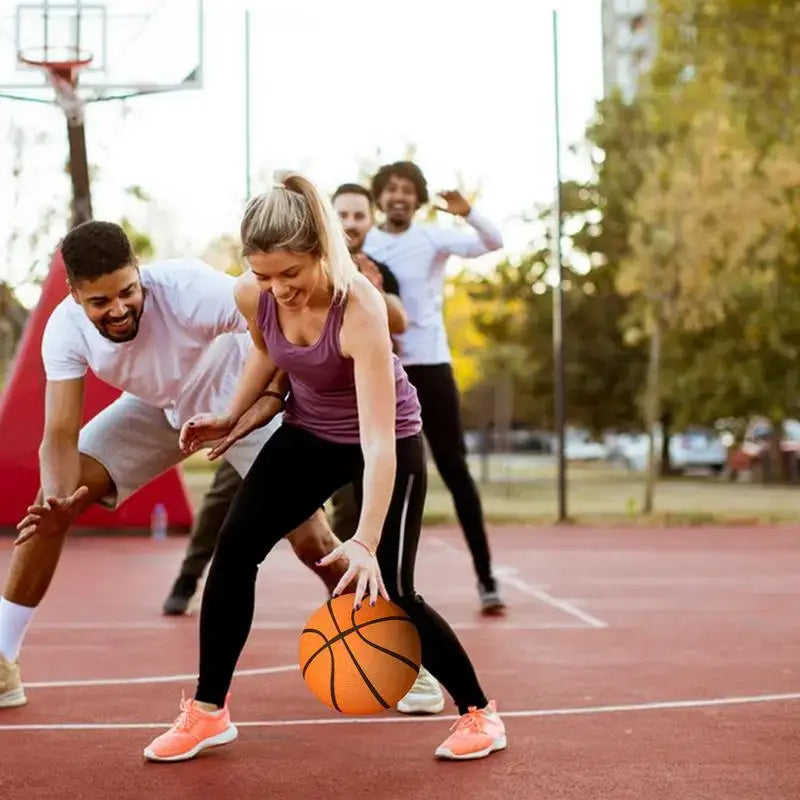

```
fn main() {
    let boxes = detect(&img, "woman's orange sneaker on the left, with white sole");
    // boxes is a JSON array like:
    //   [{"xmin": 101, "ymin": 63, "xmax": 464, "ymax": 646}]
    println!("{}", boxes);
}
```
[{"xmin": 144, "ymin": 697, "xmax": 239, "ymax": 761}]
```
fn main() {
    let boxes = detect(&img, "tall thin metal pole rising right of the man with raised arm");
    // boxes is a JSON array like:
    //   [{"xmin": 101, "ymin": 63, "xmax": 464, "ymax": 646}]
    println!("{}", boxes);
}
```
[{"xmin": 553, "ymin": 9, "xmax": 567, "ymax": 522}]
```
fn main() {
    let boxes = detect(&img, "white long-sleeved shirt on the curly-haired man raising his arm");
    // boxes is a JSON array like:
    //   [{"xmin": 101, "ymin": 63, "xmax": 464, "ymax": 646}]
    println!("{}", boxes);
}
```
[{"xmin": 364, "ymin": 209, "xmax": 503, "ymax": 365}]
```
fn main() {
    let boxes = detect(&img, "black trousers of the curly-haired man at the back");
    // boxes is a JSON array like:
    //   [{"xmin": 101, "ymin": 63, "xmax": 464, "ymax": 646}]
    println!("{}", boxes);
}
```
[{"xmin": 405, "ymin": 364, "xmax": 497, "ymax": 591}]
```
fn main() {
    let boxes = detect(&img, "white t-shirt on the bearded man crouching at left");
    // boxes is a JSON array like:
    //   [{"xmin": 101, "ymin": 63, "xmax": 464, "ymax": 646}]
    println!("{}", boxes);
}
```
[{"xmin": 42, "ymin": 259, "xmax": 250, "ymax": 428}]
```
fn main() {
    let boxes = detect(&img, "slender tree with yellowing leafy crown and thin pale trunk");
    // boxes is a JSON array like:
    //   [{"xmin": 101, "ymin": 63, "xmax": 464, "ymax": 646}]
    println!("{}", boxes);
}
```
[{"xmin": 618, "ymin": 104, "xmax": 770, "ymax": 506}]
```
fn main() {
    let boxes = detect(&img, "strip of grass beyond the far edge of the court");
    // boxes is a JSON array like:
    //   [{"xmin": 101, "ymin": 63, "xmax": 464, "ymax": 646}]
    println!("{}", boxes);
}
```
[{"xmin": 184, "ymin": 456, "xmax": 800, "ymax": 525}]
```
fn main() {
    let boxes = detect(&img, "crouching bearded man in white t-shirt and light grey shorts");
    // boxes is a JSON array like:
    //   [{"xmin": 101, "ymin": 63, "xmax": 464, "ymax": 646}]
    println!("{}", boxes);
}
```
[{"xmin": 0, "ymin": 221, "xmax": 341, "ymax": 708}]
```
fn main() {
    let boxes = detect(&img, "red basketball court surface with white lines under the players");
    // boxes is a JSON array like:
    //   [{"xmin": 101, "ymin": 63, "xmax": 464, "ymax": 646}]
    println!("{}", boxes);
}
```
[{"xmin": 0, "ymin": 528, "xmax": 800, "ymax": 800}]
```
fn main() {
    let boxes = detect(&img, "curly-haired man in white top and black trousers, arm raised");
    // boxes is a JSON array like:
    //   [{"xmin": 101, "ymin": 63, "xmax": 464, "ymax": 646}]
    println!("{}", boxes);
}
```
[{"xmin": 364, "ymin": 161, "xmax": 505, "ymax": 616}]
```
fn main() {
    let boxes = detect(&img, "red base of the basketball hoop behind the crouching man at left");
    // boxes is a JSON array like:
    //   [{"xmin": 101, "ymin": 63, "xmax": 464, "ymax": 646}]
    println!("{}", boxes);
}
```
[{"xmin": 0, "ymin": 252, "xmax": 192, "ymax": 529}]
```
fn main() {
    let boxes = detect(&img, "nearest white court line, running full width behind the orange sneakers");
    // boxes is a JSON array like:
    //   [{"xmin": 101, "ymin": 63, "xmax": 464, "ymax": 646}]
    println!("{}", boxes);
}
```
[{"xmin": 0, "ymin": 692, "xmax": 800, "ymax": 732}]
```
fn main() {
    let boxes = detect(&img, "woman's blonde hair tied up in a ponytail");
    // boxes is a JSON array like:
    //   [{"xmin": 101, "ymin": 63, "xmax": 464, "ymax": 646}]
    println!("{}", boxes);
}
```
[{"xmin": 241, "ymin": 171, "xmax": 358, "ymax": 300}]
